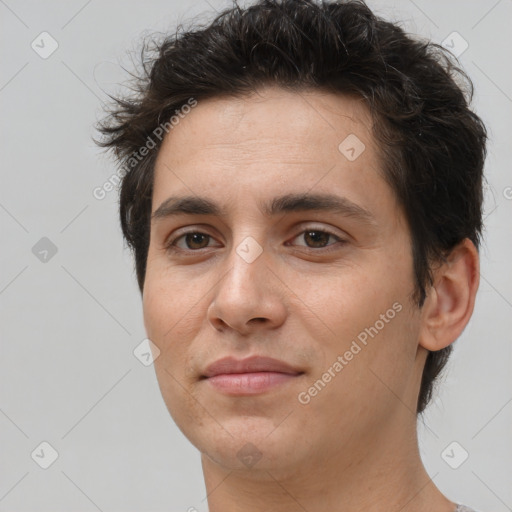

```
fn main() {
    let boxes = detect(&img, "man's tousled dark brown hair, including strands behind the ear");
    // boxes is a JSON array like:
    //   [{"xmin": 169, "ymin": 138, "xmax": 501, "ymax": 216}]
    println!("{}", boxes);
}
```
[{"xmin": 96, "ymin": 0, "xmax": 487, "ymax": 413}]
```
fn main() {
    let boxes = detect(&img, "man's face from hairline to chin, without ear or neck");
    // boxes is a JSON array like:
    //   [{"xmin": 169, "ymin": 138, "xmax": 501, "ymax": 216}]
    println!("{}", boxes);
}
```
[{"xmin": 143, "ymin": 87, "xmax": 423, "ymax": 472}]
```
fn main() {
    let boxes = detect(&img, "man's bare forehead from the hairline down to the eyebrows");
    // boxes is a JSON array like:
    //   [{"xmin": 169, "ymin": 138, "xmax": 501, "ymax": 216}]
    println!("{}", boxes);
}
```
[{"xmin": 153, "ymin": 87, "xmax": 394, "ymax": 222}]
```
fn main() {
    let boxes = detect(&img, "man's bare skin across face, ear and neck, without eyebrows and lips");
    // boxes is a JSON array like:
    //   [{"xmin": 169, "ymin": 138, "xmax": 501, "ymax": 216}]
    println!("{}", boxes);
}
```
[{"xmin": 143, "ymin": 87, "xmax": 478, "ymax": 512}]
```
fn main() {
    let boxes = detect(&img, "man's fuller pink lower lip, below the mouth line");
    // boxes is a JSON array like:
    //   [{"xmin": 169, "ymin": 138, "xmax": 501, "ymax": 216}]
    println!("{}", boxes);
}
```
[{"xmin": 207, "ymin": 372, "xmax": 301, "ymax": 395}]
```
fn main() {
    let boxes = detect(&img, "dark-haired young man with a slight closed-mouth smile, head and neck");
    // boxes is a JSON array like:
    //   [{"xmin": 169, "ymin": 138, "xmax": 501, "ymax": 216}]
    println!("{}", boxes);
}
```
[{"xmin": 97, "ymin": 0, "xmax": 486, "ymax": 512}]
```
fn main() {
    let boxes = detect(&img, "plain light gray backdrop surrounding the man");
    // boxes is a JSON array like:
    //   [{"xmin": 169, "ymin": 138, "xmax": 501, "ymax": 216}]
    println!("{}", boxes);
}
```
[{"xmin": 0, "ymin": 0, "xmax": 512, "ymax": 512}]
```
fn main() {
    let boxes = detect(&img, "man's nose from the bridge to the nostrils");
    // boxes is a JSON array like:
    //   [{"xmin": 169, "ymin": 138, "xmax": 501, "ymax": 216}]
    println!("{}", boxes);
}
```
[{"xmin": 207, "ymin": 242, "xmax": 287, "ymax": 335}]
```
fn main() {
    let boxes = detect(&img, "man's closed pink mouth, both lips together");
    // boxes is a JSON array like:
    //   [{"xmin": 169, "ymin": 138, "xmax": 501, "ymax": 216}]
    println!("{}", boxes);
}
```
[{"xmin": 201, "ymin": 356, "xmax": 304, "ymax": 396}]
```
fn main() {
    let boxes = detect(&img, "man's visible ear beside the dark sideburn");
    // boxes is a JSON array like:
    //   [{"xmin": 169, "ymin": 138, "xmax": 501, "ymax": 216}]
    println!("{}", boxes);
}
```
[{"xmin": 419, "ymin": 238, "xmax": 480, "ymax": 351}]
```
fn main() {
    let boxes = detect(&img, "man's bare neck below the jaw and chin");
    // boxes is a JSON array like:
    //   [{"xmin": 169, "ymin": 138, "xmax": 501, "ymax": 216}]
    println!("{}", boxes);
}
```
[{"xmin": 202, "ymin": 414, "xmax": 456, "ymax": 512}]
